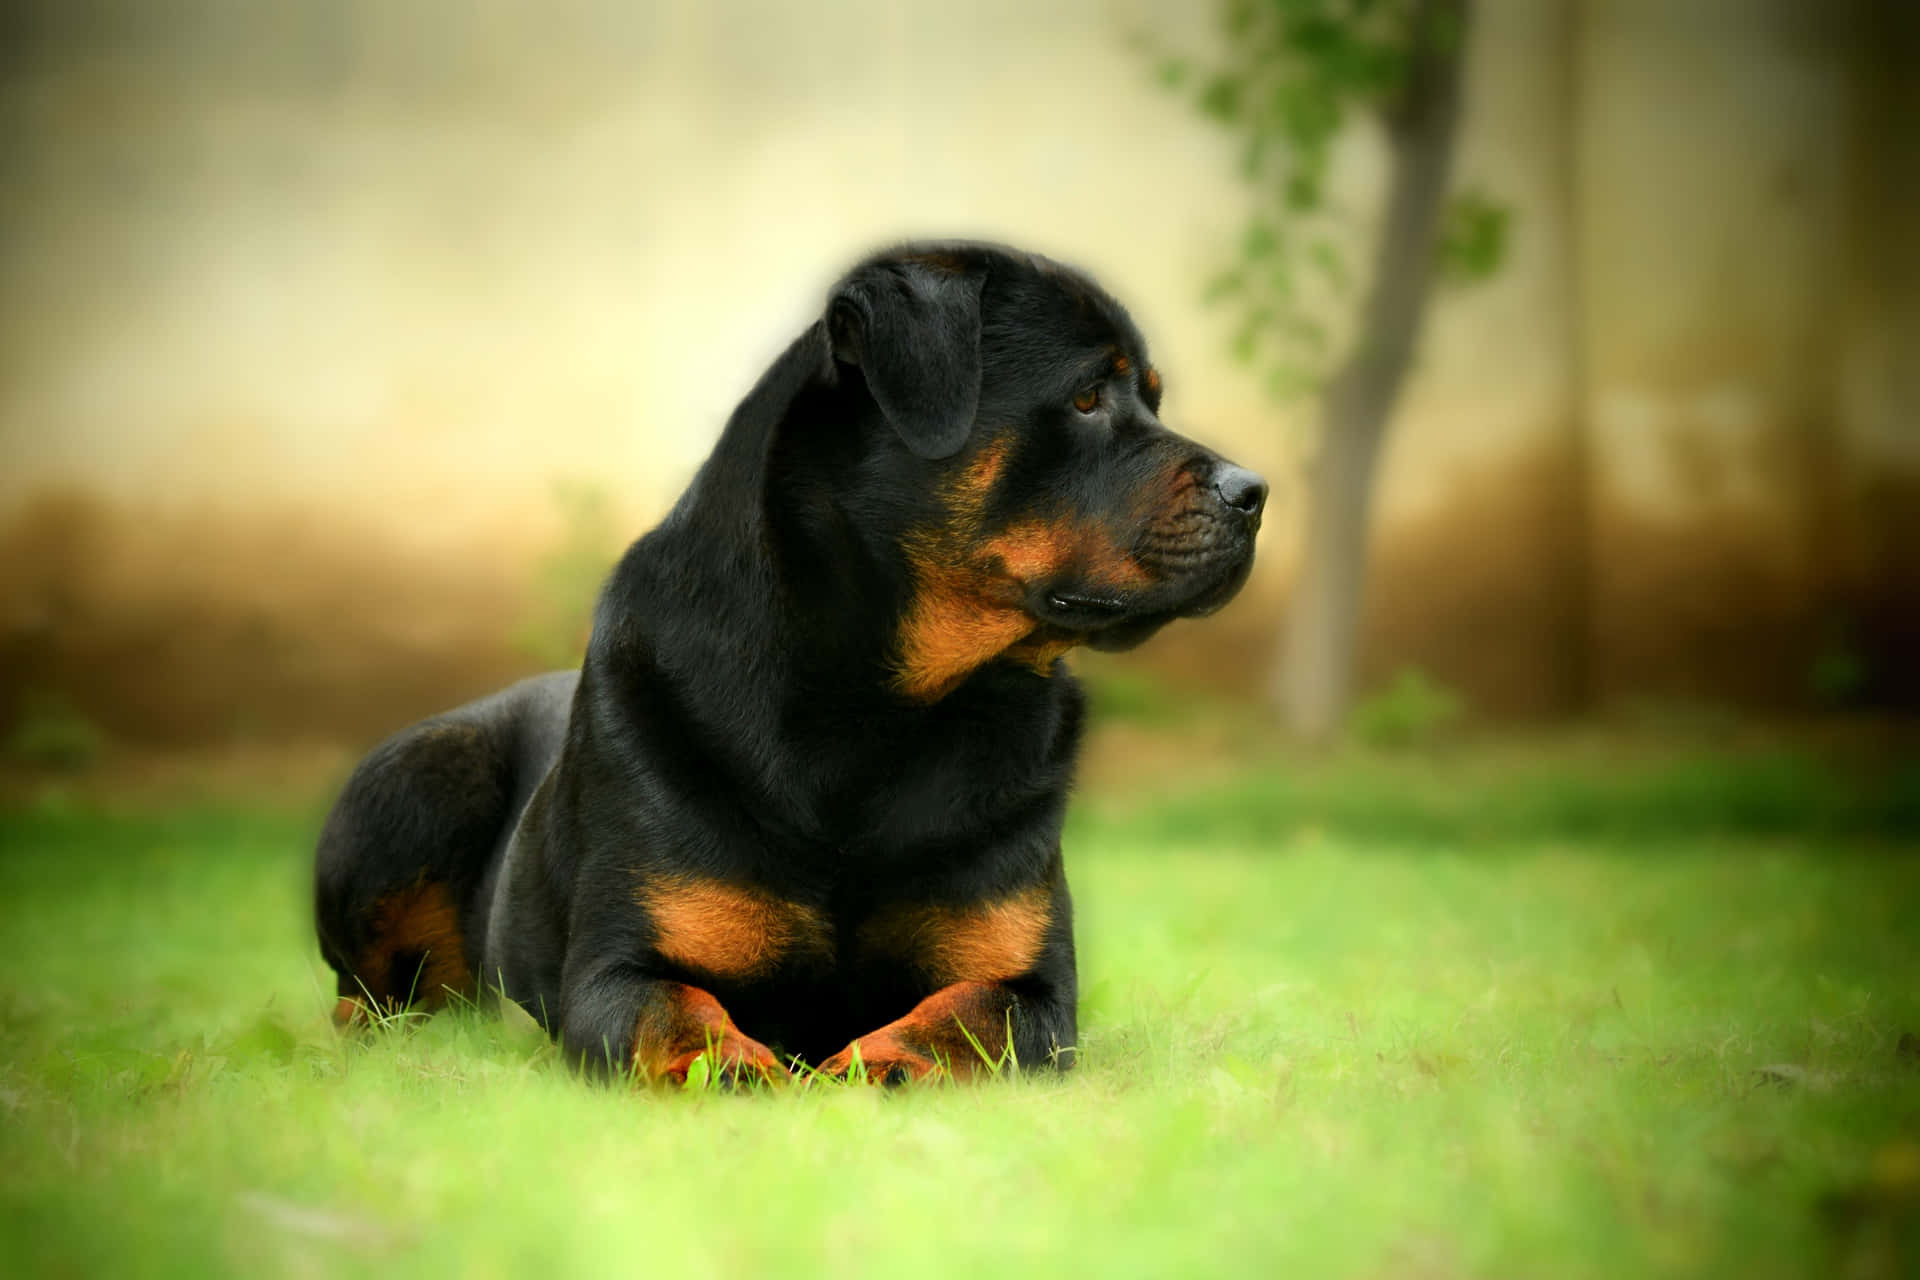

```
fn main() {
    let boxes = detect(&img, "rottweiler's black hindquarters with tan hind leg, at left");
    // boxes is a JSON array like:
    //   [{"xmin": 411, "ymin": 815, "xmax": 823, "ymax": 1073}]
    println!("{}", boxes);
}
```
[{"xmin": 313, "ymin": 672, "xmax": 580, "ymax": 1023}]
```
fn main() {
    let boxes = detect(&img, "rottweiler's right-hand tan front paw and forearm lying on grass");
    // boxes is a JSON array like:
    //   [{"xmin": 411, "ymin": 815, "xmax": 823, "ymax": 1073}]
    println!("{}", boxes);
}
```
[{"xmin": 820, "ymin": 983, "xmax": 1073, "ymax": 1084}]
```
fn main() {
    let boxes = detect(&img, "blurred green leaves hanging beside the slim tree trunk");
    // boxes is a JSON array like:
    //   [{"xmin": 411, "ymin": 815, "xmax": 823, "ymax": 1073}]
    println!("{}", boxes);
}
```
[{"xmin": 1135, "ymin": 0, "xmax": 1511, "ymax": 399}]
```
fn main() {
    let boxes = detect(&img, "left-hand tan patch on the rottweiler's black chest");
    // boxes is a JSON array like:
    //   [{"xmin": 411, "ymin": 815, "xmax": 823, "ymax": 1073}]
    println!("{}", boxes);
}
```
[{"xmin": 634, "ymin": 875, "xmax": 833, "ymax": 979}]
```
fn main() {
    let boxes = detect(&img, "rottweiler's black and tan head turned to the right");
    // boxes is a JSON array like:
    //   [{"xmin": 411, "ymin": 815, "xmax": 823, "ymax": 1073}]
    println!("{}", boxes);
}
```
[{"xmin": 826, "ymin": 244, "xmax": 1267, "ymax": 700}]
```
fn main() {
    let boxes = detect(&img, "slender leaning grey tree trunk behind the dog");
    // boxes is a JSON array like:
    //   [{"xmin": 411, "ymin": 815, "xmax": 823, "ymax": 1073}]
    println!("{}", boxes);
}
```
[{"xmin": 1275, "ymin": 0, "xmax": 1469, "ymax": 743}]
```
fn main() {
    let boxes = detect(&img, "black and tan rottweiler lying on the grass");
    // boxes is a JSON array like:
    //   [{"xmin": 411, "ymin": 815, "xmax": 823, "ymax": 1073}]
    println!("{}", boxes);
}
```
[{"xmin": 315, "ymin": 244, "xmax": 1267, "ymax": 1080}]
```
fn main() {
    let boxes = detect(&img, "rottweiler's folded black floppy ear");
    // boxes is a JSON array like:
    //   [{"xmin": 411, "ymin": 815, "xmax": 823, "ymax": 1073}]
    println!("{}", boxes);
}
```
[{"xmin": 828, "ymin": 259, "xmax": 985, "ymax": 459}]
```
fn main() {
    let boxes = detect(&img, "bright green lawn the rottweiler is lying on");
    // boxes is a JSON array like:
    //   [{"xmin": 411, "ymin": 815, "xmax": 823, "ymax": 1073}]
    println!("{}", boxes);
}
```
[{"xmin": 0, "ymin": 752, "xmax": 1920, "ymax": 1276}]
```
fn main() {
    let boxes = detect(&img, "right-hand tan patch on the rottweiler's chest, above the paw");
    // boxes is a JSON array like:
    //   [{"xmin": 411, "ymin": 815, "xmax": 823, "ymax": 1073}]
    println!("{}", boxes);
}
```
[{"xmin": 860, "ymin": 885, "xmax": 1054, "ymax": 986}]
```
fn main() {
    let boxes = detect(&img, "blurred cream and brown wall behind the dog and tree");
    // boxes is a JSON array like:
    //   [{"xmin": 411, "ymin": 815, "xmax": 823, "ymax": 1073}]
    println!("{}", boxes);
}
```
[{"xmin": 0, "ymin": 0, "xmax": 1920, "ymax": 768}]
